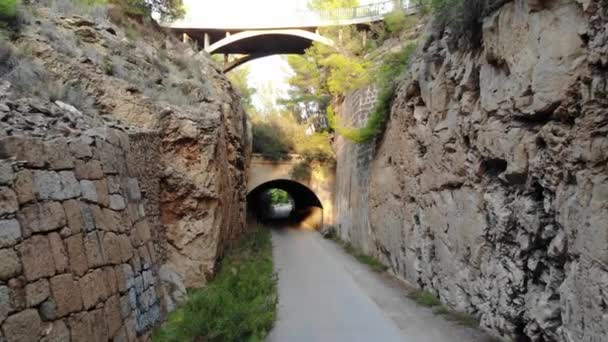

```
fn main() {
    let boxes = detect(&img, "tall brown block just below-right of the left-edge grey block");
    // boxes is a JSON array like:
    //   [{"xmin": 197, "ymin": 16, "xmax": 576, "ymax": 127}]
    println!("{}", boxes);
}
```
[{"xmin": 19, "ymin": 235, "xmax": 55, "ymax": 281}]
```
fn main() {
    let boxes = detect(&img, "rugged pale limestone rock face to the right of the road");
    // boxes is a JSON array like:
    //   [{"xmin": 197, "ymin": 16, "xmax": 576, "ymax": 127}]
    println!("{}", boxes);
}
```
[{"xmin": 336, "ymin": 0, "xmax": 608, "ymax": 341}]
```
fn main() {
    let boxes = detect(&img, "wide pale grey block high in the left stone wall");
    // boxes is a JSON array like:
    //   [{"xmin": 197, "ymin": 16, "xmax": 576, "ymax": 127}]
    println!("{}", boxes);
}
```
[{"xmin": 34, "ymin": 171, "xmax": 80, "ymax": 200}]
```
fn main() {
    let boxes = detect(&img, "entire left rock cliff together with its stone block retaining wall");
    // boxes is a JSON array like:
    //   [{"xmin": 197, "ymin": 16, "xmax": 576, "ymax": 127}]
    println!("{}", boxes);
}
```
[{"xmin": 0, "ymin": 7, "xmax": 251, "ymax": 341}]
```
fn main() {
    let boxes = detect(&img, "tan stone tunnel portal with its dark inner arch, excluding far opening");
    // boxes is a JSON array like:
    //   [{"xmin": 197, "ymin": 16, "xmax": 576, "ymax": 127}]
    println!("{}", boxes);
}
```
[{"xmin": 247, "ymin": 154, "xmax": 335, "ymax": 229}]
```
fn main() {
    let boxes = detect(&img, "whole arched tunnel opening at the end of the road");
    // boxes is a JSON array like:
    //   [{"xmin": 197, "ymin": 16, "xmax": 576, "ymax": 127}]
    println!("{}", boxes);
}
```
[{"xmin": 247, "ymin": 179, "xmax": 323, "ymax": 230}]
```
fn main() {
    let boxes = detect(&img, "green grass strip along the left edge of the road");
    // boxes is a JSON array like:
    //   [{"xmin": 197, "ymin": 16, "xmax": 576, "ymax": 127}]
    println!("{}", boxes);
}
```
[{"xmin": 153, "ymin": 228, "xmax": 278, "ymax": 342}]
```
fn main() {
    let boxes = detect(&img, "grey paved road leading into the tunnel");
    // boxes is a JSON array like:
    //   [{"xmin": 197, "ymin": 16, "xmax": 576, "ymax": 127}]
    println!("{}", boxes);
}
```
[{"xmin": 268, "ymin": 229, "xmax": 496, "ymax": 342}]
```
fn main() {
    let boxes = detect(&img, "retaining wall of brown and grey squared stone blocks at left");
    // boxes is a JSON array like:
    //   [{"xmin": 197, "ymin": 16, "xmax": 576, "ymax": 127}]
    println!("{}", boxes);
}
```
[{"xmin": 0, "ymin": 128, "xmax": 162, "ymax": 342}]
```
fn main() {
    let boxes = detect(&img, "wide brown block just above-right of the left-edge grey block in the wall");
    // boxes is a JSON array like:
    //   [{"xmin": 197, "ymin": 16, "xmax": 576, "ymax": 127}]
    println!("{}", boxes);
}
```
[{"xmin": 17, "ymin": 202, "xmax": 66, "ymax": 236}]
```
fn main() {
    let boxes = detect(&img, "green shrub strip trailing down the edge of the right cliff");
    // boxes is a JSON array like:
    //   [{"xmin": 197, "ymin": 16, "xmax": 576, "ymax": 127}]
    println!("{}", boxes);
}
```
[{"xmin": 327, "ymin": 44, "xmax": 416, "ymax": 143}]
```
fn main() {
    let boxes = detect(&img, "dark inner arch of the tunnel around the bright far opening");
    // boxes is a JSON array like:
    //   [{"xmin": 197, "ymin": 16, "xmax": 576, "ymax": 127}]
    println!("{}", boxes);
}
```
[{"xmin": 247, "ymin": 179, "xmax": 323, "ymax": 230}]
